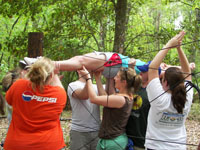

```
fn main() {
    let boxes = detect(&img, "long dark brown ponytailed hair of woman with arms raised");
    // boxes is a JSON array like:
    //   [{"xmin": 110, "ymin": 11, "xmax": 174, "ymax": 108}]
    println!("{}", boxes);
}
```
[{"xmin": 165, "ymin": 67, "xmax": 186, "ymax": 113}]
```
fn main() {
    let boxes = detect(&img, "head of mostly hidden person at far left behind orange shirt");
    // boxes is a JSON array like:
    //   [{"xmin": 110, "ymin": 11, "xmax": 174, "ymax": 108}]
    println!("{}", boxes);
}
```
[{"xmin": 2, "ymin": 68, "xmax": 21, "ymax": 92}]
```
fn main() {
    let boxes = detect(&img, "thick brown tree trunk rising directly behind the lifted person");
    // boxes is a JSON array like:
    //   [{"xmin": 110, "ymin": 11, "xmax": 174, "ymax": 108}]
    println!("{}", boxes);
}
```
[{"xmin": 113, "ymin": 0, "xmax": 127, "ymax": 53}]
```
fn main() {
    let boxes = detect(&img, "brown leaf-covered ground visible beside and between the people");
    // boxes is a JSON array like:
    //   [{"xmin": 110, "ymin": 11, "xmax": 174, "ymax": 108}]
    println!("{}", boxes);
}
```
[{"xmin": 0, "ymin": 104, "xmax": 200, "ymax": 150}]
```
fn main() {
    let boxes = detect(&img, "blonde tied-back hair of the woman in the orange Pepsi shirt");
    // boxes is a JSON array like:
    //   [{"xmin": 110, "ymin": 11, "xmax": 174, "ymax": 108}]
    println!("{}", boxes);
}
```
[{"xmin": 27, "ymin": 57, "xmax": 54, "ymax": 90}]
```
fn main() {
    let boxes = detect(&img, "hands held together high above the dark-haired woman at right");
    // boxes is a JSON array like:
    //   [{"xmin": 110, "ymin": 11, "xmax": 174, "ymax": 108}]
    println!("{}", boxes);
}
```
[{"xmin": 166, "ymin": 31, "xmax": 185, "ymax": 48}]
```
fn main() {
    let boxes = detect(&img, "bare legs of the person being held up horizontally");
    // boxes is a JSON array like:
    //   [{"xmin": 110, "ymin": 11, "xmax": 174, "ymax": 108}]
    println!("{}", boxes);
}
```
[{"xmin": 55, "ymin": 53, "xmax": 106, "ymax": 71}]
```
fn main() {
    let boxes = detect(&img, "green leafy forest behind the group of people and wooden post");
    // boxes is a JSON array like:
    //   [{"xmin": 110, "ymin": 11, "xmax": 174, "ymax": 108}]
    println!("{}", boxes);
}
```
[{"xmin": 0, "ymin": 0, "xmax": 200, "ymax": 105}]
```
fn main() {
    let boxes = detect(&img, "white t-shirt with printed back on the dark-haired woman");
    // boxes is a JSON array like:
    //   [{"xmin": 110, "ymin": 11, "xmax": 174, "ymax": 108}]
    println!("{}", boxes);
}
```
[{"xmin": 145, "ymin": 78, "xmax": 193, "ymax": 150}]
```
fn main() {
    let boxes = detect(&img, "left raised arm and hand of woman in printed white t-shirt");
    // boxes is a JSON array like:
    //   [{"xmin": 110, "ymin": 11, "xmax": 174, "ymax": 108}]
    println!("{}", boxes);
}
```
[{"xmin": 148, "ymin": 31, "xmax": 185, "ymax": 81}]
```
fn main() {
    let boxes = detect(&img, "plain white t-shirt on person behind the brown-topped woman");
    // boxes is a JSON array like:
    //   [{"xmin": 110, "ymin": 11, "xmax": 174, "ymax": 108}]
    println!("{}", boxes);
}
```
[{"xmin": 67, "ymin": 81, "xmax": 100, "ymax": 132}]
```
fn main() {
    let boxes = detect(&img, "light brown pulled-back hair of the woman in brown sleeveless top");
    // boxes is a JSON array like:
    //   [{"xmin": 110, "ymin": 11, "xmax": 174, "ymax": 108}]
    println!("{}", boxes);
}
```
[{"xmin": 120, "ymin": 68, "xmax": 142, "ymax": 93}]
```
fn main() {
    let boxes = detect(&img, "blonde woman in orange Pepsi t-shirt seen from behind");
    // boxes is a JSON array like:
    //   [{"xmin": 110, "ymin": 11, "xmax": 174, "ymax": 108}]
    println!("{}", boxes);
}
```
[{"xmin": 4, "ymin": 57, "xmax": 67, "ymax": 150}]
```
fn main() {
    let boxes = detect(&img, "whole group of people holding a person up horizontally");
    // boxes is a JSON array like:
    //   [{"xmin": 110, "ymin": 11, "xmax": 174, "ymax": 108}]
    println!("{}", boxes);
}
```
[{"xmin": 0, "ymin": 31, "xmax": 197, "ymax": 150}]
